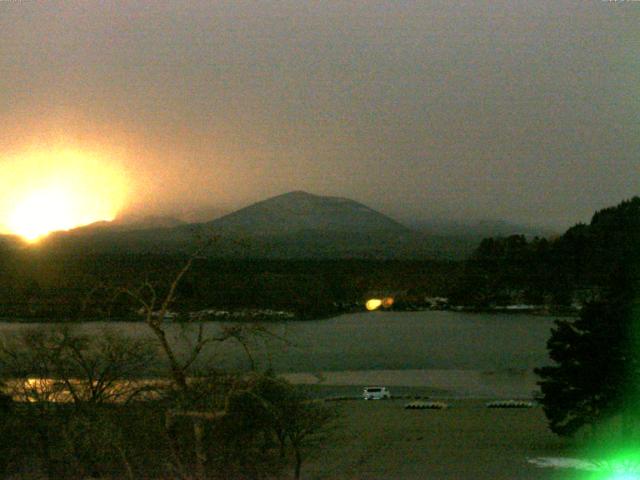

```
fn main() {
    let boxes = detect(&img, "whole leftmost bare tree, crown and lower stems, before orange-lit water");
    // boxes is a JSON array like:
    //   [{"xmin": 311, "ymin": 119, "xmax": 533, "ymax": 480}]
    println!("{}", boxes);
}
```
[{"xmin": 0, "ymin": 326, "xmax": 155, "ymax": 478}]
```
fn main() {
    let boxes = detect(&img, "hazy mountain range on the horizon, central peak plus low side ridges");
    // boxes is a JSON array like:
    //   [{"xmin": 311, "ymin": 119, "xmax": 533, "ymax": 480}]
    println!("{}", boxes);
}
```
[{"xmin": 18, "ymin": 191, "xmax": 544, "ymax": 260}]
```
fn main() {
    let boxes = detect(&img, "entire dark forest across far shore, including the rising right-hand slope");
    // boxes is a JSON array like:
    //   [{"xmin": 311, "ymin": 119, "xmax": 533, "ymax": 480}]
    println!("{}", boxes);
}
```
[{"xmin": 0, "ymin": 197, "xmax": 640, "ymax": 320}]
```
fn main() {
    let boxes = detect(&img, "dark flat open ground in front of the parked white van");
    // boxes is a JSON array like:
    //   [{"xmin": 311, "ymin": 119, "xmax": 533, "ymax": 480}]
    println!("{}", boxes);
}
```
[{"xmin": 304, "ymin": 400, "xmax": 575, "ymax": 480}]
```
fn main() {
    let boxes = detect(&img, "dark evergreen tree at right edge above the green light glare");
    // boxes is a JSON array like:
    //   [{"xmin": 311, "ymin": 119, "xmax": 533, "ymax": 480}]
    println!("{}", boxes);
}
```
[{"xmin": 536, "ymin": 272, "xmax": 640, "ymax": 435}]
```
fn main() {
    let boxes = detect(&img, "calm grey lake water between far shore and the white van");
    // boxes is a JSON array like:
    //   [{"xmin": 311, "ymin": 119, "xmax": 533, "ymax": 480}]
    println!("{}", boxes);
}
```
[{"xmin": 0, "ymin": 311, "xmax": 553, "ymax": 374}]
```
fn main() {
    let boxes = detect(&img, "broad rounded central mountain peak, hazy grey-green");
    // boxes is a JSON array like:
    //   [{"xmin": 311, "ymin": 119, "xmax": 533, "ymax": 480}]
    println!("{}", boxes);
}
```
[{"xmin": 185, "ymin": 191, "xmax": 415, "ymax": 258}]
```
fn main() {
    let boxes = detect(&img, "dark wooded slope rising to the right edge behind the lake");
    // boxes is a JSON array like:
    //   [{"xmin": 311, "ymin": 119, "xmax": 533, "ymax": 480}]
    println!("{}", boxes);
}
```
[{"xmin": 454, "ymin": 197, "xmax": 640, "ymax": 305}]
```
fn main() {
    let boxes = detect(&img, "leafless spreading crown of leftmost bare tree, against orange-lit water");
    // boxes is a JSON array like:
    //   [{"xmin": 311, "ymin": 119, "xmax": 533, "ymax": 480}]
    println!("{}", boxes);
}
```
[{"xmin": 0, "ymin": 326, "xmax": 155, "ymax": 408}]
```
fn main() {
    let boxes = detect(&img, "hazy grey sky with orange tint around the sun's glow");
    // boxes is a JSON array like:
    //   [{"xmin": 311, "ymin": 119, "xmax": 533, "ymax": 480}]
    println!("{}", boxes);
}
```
[{"xmin": 0, "ymin": 0, "xmax": 640, "ymax": 227}]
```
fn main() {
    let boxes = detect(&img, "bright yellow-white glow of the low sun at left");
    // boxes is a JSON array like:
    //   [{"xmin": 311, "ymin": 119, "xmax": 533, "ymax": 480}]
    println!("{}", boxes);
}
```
[{"xmin": 0, "ymin": 149, "xmax": 128, "ymax": 242}]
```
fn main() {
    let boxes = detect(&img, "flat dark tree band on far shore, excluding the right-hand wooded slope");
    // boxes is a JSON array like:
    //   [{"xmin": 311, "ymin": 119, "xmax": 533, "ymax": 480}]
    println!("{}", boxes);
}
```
[{"xmin": 0, "ymin": 253, "xmax": 461, "ymax": 320}]
